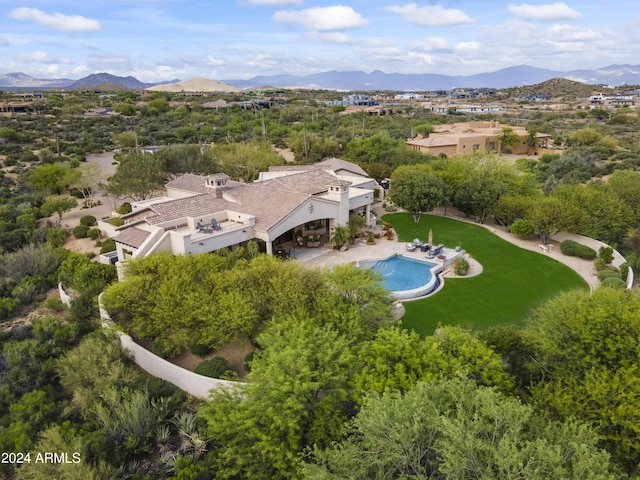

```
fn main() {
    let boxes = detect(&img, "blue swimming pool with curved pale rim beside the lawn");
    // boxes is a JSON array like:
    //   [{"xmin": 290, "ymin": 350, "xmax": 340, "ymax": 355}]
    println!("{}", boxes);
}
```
[{"xmin": 360, "ymin": 255, "xmax": 442, "ymax": 299}]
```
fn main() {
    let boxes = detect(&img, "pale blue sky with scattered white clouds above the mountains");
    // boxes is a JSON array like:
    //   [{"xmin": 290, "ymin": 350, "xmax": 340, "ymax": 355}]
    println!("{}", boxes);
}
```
[{"xmin": 0, "ymin": 0, "xmax": 640, "ymax": 82}]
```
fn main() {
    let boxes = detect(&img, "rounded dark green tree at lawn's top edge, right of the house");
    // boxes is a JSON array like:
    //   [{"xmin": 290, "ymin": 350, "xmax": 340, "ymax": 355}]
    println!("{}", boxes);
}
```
[{"xmin": 390, "ymin": 165, "xmax": 446, "ymax": 223}]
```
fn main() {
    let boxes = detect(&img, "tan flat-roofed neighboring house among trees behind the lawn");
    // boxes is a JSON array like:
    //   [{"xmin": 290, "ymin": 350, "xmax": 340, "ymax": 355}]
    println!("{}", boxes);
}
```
[{"xmin": 407, "ymin": 121, "xmax": 551, "ymax": 157}]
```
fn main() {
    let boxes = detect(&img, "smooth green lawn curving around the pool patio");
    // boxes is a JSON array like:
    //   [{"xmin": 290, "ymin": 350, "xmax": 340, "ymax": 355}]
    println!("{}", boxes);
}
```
[{"xmin": 383, "ymin": 213, "xmax": 589, "ymax": 335}]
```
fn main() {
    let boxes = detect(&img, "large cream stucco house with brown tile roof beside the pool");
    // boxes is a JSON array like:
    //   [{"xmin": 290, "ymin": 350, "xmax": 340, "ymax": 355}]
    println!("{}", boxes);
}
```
[{"xmin": 113, "ymin": 158, "xmax": 380, "ymax": 276}]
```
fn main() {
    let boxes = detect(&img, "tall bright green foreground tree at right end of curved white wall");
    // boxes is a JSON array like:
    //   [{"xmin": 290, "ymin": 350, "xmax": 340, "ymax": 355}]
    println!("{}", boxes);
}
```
[{"xmin": 202, "ymin": 317, "xmax": 357, "ymax": 479}]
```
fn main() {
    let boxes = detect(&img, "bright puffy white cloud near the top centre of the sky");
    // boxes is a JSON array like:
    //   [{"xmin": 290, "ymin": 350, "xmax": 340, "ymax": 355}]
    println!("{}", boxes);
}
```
[{"xmin": 273, "ymin": 5, "xmax": 369, "ymax": 31}]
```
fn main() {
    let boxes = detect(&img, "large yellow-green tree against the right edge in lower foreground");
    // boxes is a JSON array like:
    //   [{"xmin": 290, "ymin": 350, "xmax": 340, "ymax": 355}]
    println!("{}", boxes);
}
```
[{"xmin": 525, "ymin": 287, "xmax": 640, "ymax": 474}]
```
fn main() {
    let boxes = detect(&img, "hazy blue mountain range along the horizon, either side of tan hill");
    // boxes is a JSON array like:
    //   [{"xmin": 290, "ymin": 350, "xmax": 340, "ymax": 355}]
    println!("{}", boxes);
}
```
[{"xmin": 0, "ymin": 65, "xmax": 640, "ymax": 91}]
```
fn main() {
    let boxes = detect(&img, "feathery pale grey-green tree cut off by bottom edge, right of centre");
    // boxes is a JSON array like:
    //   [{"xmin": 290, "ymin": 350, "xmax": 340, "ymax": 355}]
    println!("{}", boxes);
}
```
[{"xmin": 303, "ymin": 379, "xmax": 616, "ymax": 480}]
